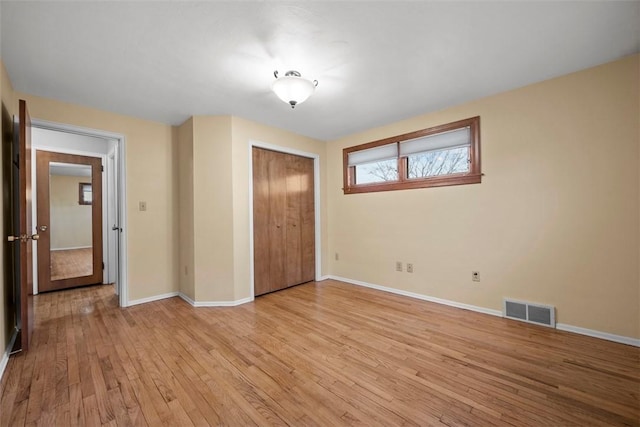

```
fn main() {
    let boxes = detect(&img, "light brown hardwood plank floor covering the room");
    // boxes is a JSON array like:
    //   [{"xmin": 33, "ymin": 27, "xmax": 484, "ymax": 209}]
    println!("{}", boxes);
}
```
[{"xmin": 0, "ymin": 281, "xmax": 640, "ymax": 426}]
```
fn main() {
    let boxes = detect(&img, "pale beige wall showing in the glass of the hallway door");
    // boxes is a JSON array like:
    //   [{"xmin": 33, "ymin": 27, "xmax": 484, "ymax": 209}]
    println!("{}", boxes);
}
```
[{"xmin": 49, "ymin": 175, "xmax": 92, "ymax": 250}]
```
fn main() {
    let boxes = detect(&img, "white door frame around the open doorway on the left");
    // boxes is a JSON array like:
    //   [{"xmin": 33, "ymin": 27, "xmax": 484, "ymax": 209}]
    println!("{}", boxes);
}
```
[{"xmin": 31, "ymin": 119, "xmax": 129, "ymax": 307}]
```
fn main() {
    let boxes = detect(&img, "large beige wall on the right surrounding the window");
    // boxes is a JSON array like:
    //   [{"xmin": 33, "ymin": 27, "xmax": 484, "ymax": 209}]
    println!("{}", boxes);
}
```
[{"xmin": 327, "ymin": 55, "xmax": 640, "ymax": 338}]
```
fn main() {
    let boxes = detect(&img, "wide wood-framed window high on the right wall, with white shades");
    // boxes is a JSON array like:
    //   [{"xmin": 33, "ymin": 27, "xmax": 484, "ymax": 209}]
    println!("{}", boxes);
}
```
[{"xmin": 342, "ymin": 117, "xmax": 482, "ymax": 194}]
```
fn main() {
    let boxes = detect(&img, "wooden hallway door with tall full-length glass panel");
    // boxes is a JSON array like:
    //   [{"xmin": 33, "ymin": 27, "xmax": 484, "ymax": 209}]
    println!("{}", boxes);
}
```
[{"xmin": 36, "ymin": 150, "xmax": 103, "ymax": 292}]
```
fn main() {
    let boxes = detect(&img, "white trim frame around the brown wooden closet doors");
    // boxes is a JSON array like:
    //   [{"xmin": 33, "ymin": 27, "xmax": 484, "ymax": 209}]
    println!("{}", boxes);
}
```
[{"xmin": 249, "ymin": 141, "xmax": 322, "ymax": 301}]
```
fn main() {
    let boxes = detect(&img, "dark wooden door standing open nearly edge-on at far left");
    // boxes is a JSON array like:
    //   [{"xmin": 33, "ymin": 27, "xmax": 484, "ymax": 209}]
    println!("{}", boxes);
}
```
[{"xmin": 7, "ymin": 99, "xmax": 39, "ymax": 351}]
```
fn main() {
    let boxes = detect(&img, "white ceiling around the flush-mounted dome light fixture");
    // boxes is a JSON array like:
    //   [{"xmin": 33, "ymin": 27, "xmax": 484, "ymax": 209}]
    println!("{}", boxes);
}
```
[{"xmin": 0, "ymin": 1, "xmax": 640, "ymax": 140}]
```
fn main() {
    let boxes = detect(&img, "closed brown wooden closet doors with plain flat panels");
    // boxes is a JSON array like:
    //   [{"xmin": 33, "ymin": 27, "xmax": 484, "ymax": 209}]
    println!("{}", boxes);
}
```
[{"xmin": 252, "ymin": 146, "xmax": 316, "ymax": 296}]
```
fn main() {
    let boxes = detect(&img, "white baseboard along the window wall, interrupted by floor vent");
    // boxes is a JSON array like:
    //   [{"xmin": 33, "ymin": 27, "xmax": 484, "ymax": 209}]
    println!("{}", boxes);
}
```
[{"xmin": 327, "ymin": 275, "xmax": 640, "ymax": 347}]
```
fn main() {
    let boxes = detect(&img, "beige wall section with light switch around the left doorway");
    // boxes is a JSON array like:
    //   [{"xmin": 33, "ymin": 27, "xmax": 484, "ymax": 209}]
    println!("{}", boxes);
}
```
[{"xmin": 17, "ymin": 93, "xmax": 178, "ymax": 300}]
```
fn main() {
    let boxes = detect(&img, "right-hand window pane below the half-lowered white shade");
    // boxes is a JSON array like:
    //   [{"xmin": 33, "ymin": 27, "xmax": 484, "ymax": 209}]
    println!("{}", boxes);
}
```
[{"xmin": 407, "ymin": 147, "xmax": 469, "ymax": 179}]
